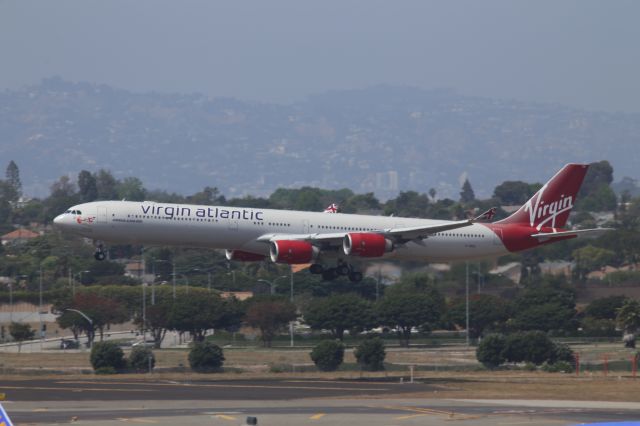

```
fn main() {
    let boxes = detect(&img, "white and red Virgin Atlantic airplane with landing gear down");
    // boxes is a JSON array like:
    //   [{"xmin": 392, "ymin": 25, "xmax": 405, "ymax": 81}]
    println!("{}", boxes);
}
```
[{"xmin": 53, "ymin": 164, "xmax": 609, "ymax": 282}]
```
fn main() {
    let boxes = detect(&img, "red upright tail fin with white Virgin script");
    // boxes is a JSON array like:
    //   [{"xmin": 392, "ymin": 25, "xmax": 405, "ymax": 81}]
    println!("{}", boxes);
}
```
[{"xmin": 497, "ymin": 164, "xmax": 589, "ymax": 230}]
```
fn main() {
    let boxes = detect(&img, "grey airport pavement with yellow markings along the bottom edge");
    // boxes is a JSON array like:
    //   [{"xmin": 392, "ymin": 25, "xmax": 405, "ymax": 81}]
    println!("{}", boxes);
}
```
[{"xmin": 0, "ymin": 380, "xmax": 640, "ymax": 426}]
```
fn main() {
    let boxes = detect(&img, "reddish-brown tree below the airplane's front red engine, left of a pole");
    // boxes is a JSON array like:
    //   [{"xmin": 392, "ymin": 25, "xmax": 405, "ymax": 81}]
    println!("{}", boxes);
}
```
[{"xmin": 246, "ymin": 299, "xmax": 297, "ymax": 348}]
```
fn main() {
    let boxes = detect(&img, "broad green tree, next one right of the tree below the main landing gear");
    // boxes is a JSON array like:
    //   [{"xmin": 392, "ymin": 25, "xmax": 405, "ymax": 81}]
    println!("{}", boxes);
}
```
[{"xmin": 376, "ymin": 283, "xmax": 444, "ymax": 347}]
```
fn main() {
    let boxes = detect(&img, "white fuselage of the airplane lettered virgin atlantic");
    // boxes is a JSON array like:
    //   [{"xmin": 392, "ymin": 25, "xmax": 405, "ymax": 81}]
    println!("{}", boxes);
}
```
[{"xmin": 54, "ymin": 201, "xmax": 508, "ymax": 261}]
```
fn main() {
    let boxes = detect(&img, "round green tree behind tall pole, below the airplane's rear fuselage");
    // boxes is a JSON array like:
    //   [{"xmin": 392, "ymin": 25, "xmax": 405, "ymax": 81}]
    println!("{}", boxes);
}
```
[{"xmin": 446, "ymin": 294, "xmax": 512, "ymax": 338}]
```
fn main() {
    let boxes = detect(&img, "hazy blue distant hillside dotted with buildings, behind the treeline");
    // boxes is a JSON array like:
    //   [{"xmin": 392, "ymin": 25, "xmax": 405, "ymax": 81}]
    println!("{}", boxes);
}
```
[{"xmin": 0, "ymin": 78, "xmax": 640, "ymax": 198}]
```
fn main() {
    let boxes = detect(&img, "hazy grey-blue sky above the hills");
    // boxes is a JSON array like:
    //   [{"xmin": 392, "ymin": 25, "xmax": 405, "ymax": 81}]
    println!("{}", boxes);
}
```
[{"xmin": 0, "ymin": 0, "xmax": 640, "ymax": 112}]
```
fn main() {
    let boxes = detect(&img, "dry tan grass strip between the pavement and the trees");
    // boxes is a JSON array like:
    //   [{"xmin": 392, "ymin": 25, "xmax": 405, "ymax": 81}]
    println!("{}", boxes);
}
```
[{"xmin": 0, "ymin": 344, "xmax": 640, "ymax": 402}]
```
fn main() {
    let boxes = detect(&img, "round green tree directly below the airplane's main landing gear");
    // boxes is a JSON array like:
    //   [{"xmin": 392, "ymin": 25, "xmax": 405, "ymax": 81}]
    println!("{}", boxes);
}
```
[{"xmin": 304, "ymin": 294, "xmax": 373, "ymax": 340}]
